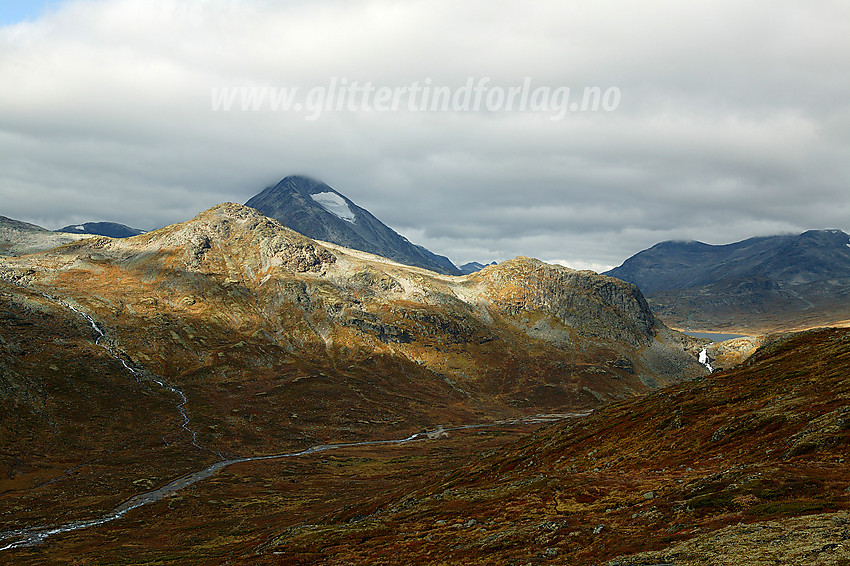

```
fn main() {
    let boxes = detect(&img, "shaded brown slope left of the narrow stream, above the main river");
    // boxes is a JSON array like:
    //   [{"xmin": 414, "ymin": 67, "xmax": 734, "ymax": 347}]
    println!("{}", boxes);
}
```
[{"xmin": 0, "ymin": 282, "xmax": 215, "ymax": 536}]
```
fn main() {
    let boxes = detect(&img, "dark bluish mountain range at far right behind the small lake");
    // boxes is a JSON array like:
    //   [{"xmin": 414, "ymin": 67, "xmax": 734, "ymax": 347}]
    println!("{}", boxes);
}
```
[{"xmin": 605, "ymin": 230, "xmax": 850, "ymax": 330}]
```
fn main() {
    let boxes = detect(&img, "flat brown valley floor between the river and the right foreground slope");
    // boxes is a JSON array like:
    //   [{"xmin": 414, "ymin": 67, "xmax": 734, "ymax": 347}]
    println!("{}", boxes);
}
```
[{"xmin": 0, "ymin": 423, "xmax": 541, "ymax": 564}]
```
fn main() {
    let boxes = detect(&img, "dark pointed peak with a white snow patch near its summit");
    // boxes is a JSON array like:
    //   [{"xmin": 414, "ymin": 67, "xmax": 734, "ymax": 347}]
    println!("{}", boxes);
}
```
[{"xmin": 245, "ymin": 175, "xmax": 462, "ymax": 275}]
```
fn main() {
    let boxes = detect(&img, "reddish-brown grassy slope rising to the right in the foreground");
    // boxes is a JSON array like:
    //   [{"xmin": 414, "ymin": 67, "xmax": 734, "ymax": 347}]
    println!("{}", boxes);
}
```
[{"xmin": 264, "ymin": 329, "xmax": 850, "ymax": 565}]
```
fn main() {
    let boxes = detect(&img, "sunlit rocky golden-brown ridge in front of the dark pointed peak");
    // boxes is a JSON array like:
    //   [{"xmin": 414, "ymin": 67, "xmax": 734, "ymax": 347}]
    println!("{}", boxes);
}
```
[{"xmin": 1, "ymin": 204, "xmax": 698, "ymax": 400}]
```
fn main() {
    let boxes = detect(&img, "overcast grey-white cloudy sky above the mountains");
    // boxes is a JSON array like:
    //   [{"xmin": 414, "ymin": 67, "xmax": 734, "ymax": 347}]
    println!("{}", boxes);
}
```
[{"xmin": 0, "ymin": 0, "xmax": 850, "ymax": 270}]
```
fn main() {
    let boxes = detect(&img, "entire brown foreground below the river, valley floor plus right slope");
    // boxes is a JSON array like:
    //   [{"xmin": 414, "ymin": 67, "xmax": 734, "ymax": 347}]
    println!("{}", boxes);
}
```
[{"xmin": 5, "ymin": 316, "xmax": 850, "ymax": 566}]
